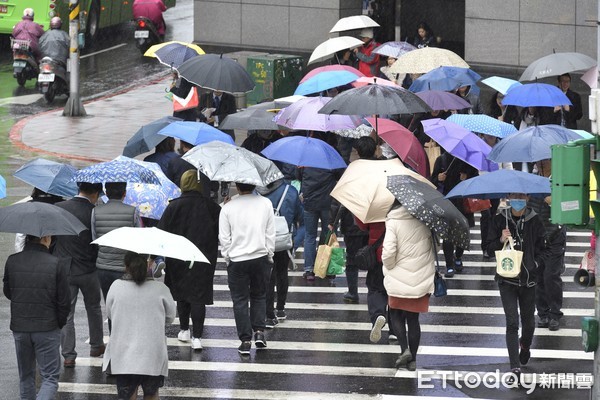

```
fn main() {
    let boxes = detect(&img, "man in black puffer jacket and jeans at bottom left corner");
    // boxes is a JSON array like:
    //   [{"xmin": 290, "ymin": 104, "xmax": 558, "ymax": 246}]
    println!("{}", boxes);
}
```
[{"xmin": 4, "ymin": 236, "xmax": 70, "ymax": 399}]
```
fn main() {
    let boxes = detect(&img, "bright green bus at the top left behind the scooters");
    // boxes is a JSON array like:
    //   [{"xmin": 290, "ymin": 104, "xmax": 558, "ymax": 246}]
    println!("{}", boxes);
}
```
[{"xmin": 0, "ymin": 0, "xmax": 176, "ymax": 45}]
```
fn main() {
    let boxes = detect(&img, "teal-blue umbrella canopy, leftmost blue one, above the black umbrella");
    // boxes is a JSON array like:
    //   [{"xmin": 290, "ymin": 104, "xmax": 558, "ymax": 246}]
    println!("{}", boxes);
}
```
[{"xmin": 13, "ymin": 158, "xmax": 78, "ymax": 197}]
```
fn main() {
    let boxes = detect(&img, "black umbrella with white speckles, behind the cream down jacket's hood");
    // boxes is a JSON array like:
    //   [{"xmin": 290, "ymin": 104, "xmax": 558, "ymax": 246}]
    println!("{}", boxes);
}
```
[{"xmin": 387, "ymin": 175, "xmax": 470, "ymax": 249}]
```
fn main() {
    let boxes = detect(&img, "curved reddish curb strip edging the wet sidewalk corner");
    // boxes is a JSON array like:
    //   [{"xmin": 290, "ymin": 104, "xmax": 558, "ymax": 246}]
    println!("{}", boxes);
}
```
[{"xmin": 8, "ymin": 73, "xmax": 169, "ymax": 163}]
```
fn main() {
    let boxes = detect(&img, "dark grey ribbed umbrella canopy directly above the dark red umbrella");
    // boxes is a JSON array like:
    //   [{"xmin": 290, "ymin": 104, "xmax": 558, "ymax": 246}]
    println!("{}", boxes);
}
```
[{"xmin": 319, "ymin": 83, "xmax": 431, "ymax": 115}]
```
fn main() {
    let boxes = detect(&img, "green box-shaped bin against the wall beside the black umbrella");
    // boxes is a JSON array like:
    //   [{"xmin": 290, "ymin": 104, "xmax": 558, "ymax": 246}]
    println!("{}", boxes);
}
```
[{"xmin": 246, "ymin": 54, "xmax": 304, "ymax": 105}]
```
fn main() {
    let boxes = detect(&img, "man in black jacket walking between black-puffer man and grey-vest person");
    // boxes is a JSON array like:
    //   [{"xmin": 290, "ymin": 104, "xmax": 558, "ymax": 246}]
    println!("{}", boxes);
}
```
[{"xmin": 54, "ymin": 182, "xmax": 104, "ymax": 368}]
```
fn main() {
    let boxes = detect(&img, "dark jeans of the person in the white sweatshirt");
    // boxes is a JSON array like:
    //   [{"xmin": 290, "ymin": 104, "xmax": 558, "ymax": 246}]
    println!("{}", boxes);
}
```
[{"xmin": 227, "ymin": 256, "xmax": 271, "ymax": 341}]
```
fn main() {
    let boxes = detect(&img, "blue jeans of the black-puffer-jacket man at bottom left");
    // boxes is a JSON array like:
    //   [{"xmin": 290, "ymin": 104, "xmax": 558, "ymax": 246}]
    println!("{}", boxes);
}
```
[{"xmin": 13, "ymin": 329, "xmax": 60, "ymax": 400}]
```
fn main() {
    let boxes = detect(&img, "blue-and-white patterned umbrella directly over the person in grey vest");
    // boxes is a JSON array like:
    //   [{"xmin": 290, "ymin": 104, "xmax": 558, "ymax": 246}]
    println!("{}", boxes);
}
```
[{"xmin": 72, "ymin": 160, "xmax": 160, "ymax": 185}]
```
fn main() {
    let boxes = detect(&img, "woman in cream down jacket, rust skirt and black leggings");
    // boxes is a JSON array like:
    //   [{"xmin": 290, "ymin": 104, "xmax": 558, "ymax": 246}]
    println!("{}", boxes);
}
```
[{"xmin": 382, "ymin": 202, "xmax": 435, "ymax": 371}]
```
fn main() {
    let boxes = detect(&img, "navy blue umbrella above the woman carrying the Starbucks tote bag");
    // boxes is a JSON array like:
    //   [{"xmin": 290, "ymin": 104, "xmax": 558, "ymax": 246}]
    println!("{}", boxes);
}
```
[{"xmin": 446, "ymin": 169, "xmax": 550, "ymax": 199}]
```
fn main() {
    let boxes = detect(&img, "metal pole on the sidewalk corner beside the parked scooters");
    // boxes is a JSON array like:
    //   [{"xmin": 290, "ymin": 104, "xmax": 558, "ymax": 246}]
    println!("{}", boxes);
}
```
[{"xmin": 63, "ymin": 0, "xmax": 86, "ymax": 117}]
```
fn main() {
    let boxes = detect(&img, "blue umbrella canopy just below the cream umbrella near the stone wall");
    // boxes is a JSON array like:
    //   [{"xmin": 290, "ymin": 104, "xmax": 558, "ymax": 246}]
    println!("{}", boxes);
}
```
[{"xmin": 409, "ymin": 66, "xmax": 481, "ymax": 92}]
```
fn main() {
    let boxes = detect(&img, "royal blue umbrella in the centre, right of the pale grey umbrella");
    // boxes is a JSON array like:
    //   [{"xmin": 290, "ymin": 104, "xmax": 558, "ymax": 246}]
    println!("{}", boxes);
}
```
[{"xmin": 261, "ymin": 136, "xmax": 346, "ymax": 169}]
